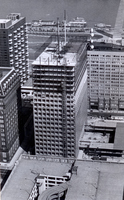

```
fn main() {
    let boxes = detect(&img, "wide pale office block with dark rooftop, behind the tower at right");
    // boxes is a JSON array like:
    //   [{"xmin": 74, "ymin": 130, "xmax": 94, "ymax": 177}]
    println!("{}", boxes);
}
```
[{"xmin": 87, "ymin": 42, "xmax": 124, "ymax": 113}]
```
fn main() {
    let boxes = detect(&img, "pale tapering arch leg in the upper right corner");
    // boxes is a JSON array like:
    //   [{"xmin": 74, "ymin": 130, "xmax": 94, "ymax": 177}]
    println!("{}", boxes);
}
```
[{"xmin": 113, "ymin": 0, "xmax": 124, "ymax": 39}]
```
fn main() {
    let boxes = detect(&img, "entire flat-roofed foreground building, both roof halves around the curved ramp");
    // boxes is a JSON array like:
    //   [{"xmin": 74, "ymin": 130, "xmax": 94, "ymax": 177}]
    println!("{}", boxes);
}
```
[{"xmin": 1, "ymin": 155, "xmax": 124, "ymax": 200}]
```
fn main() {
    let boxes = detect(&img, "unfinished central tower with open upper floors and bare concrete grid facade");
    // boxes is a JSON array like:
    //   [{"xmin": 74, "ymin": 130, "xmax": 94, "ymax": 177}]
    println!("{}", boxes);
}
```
[{"xmin": 33, "ymin": 43, "xmax": 87, "ymax": 157}]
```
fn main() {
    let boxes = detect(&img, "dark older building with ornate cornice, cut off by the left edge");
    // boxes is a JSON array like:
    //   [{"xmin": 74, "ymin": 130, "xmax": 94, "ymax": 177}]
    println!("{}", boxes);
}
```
[{"xmin": 0, "ymin": 67, "xmax": 20, "ymax": 162}]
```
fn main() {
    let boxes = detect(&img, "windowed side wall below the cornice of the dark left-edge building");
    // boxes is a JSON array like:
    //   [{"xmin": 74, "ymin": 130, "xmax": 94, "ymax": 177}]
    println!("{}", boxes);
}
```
[{"xmin": 4, "ymin": 85, "xmax": 19, "ymax": 161}]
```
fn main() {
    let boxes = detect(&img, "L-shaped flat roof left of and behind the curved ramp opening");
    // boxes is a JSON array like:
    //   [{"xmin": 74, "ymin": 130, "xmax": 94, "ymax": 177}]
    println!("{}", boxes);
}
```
[{"xmin": 1, "ymin": 155, "xmax": 72, "ymax": 200}]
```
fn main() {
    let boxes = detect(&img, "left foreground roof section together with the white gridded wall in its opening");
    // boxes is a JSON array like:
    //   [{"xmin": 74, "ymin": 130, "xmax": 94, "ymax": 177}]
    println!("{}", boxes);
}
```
[{"xmin": 1, "ymin": 154, "xmax": 74, "ymax": 200}]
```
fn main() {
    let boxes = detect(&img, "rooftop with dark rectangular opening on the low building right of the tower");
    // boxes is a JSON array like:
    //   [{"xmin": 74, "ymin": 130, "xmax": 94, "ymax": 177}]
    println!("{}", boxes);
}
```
[{"xmin": 79, "ymin": 117, "xmax": 124, "ymax": 150}]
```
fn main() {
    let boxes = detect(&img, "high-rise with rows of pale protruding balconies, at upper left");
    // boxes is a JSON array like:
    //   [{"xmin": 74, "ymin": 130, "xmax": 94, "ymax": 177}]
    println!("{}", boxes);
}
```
[{"xmin": 0, "ymin": 13, "xmax": 28, "ymax": 85}]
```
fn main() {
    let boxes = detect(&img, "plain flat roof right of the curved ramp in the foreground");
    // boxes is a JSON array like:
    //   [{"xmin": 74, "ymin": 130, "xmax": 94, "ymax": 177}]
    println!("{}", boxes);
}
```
[{"xmin": 65, "ymin": 160, "xmax": 124, "ymax": 200}]
